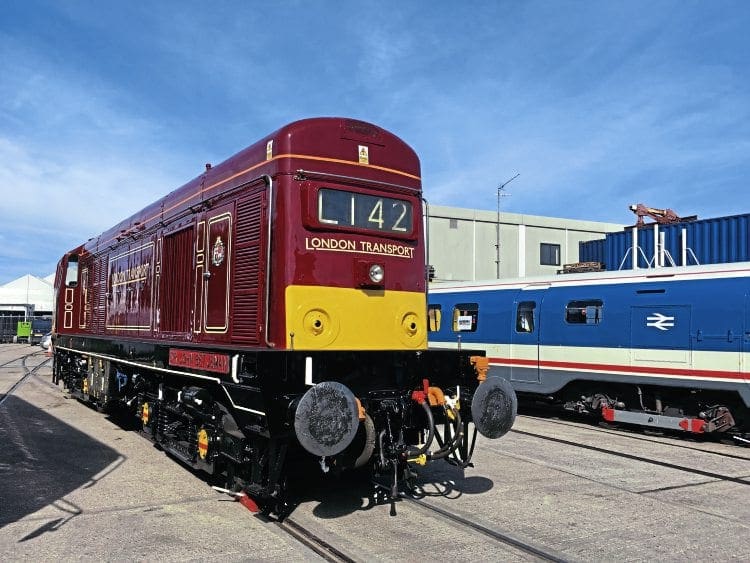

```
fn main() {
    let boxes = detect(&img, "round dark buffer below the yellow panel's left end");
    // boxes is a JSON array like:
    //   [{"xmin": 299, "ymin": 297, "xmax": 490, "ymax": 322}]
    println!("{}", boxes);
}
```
[{"xmin": 294, "ymin": 381, "xmax": 359, "ymax": 457}]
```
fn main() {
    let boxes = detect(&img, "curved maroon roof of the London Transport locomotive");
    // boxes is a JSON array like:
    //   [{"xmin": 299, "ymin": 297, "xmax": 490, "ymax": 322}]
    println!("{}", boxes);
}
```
[{"xmin": 72, "ymin": 117, "xmax": 421, "ymax": 260}]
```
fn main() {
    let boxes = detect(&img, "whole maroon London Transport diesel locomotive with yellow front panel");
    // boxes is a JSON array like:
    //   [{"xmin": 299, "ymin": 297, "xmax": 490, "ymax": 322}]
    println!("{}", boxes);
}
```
[{"xmin": 54, "ymin": 118, "xmax": 516, "ymax": 513}]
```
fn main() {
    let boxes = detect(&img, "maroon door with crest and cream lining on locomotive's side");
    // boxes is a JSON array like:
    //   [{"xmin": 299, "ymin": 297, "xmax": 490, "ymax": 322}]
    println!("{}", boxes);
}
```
[{"xmin": 194, "ymin": 203, "xmax": 234, "ymax": 337}]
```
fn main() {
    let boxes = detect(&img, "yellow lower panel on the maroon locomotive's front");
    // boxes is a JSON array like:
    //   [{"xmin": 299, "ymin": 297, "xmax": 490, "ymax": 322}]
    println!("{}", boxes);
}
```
[{"xmin": 286, "ymin": 285, "xmax": 427, "ymax": 350}]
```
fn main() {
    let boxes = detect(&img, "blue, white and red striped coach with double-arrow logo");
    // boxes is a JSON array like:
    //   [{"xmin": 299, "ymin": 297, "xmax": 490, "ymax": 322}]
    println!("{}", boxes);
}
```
[{"xmin": 430, "ymin": 264, "xmax": 750, "ymax": 433}]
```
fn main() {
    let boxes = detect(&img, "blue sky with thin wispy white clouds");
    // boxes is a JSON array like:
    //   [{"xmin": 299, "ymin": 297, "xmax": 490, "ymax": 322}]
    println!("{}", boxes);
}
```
[{"xmin": 0, "ymin": 0, "xmax": 750, "ymax": 283}]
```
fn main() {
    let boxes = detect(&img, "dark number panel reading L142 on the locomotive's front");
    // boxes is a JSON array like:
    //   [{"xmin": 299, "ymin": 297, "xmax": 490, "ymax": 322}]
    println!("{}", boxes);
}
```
[{"xmin": 317, "ymin": 188, "xmax": 413, "ymax": 235}]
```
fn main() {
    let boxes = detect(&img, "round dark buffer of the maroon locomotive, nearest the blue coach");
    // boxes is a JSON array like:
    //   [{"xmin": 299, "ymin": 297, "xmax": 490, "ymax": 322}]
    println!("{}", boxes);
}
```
[{"xmin": 471, "ymin": 376, "xmax": 518, "ymax": 438}]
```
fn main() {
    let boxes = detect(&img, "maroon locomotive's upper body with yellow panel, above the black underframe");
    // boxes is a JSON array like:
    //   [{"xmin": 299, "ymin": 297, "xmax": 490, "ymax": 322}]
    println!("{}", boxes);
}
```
[{"xmin": 58, "ymin": 120, "xmax": 426, "ymax": 349}]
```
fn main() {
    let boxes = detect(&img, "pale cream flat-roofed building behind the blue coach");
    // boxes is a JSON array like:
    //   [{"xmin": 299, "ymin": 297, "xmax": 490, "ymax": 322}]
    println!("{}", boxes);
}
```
[{"xmin": 428, "ymin": 205, "xmax": 624, "ymax": 281}]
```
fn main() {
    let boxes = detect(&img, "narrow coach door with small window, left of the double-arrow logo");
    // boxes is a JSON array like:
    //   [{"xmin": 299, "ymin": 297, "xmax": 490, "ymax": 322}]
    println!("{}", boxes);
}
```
[{"xmin": 510, "ymin": 293, "xmax": 542, "ymax": 383}]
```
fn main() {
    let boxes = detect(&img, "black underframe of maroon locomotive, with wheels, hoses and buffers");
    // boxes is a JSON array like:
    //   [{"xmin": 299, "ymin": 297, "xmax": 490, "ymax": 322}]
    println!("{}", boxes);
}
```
[{"xmin": 56, "ymin": 339, "xmax": 515, "ymax": 511}]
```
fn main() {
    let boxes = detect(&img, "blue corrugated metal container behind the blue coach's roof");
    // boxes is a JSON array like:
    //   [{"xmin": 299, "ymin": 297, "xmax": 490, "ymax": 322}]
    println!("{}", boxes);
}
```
[{"xmin": 579, "ymin": 213, "xmax": 750, "ymax": 270}]
